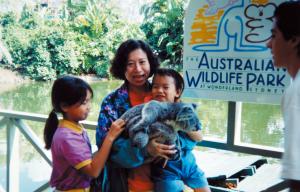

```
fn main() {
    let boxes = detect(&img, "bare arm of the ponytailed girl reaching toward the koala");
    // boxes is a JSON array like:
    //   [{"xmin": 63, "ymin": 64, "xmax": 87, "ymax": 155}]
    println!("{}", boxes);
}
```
[{"xmin": 81, "ymin": 119, "xmax": 125, "ymax": 178}]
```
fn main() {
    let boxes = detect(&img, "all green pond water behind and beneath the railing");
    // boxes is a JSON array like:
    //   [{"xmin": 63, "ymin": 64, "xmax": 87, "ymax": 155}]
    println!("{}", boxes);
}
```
[{"xmin": 0, "ymin": 81, "xmax": 283, "ymax": 191}]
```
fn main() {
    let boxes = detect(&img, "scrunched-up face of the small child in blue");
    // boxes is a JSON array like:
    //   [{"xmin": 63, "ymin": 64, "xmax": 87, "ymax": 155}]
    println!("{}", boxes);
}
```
[{"xmin": 152, "ymin": 75, "xmax": 180, "ymax": 102}]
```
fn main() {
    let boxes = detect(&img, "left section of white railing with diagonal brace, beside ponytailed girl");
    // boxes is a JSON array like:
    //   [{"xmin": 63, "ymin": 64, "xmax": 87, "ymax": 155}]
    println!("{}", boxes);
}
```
[{"xmin": 0, "ymin": 110, "xmax": 96, "ymax": 192}]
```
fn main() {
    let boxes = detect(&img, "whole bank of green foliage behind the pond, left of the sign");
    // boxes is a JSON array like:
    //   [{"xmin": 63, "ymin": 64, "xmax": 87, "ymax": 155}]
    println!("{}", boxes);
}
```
[{"xmin": 0, "ymin": 0, "xmax": 188, "ymax": 80}]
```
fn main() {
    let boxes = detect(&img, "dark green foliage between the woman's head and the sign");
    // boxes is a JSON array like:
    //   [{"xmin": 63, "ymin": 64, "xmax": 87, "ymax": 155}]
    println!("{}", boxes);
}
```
[{"xmin": 141, "ymin": 0, "xmax": 185, "ymax": 70}]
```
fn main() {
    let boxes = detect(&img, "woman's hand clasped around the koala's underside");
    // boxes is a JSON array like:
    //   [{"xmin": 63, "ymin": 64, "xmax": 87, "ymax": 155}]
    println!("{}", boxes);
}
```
[{"xmin": 147, "ymin": 138, "xmax": 177, "ymax": 159}]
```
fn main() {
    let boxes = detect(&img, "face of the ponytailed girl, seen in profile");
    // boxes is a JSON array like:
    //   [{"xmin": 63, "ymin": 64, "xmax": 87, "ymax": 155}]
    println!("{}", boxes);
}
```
[{"xmin": 62, "ymin": 90, "xmax": 92, "ymax": 123}]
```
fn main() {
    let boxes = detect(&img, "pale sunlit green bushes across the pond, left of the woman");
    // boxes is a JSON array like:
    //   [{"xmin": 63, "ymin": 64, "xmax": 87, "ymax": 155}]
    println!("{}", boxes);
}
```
[{"xmin": 0, "ymin": 0, "xmax": 143, "ymax": 80}]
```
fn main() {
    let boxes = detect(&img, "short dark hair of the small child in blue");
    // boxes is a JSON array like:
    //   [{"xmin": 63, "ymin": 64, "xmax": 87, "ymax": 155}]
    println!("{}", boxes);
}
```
[{"xmin": 154, "ymin": 68, "xmax": 184, "ymax": 97}]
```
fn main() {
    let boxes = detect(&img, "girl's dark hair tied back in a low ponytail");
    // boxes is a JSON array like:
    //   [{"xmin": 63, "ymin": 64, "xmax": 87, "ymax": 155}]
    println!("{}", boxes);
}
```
[{"xmin": 44, "ymin": 76, "xmax": 93, "ymax": 149}]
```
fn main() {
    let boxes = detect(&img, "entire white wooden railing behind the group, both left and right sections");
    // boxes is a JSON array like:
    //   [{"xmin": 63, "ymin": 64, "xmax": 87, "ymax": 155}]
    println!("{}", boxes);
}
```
[{"xmin": 0, "ymin": 109, "xmax": 282, "ymax": 192}]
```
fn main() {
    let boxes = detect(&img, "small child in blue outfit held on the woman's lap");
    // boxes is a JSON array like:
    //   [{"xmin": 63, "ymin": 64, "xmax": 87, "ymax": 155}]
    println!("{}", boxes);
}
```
[{"xmin": 151, "ymin": 69, "xmax": 210, "ymax": 192}]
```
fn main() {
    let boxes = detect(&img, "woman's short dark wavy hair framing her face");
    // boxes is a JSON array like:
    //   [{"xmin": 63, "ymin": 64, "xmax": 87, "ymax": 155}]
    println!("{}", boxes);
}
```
[{"xmin": 110, "ymin": 39, "xmax": 159, "ymax": 80}]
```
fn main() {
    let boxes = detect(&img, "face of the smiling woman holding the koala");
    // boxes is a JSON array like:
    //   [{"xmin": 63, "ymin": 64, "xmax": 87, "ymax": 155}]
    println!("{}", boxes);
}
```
[{"xmin": 125, "ymin": 49, "xmax": 150, "ymax": 87}]
